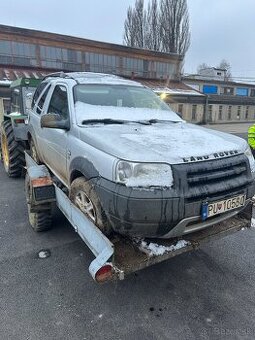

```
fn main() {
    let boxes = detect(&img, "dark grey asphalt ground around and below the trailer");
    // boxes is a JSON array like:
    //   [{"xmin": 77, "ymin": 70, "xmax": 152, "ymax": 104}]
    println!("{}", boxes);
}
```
[{"xmin": 0, "ymin": 125, "xmax": 255, "ymax": 340}]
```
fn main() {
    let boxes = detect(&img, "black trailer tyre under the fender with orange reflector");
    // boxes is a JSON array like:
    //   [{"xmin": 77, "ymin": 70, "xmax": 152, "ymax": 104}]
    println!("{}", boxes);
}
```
[{"xmin": 25, "ymin": 175, "xmax": 52, "ymax": 232}]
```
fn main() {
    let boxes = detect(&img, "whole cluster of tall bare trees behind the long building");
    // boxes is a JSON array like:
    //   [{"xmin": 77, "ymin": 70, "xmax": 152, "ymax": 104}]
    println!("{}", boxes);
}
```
[{"xmin": 124, "ymin": 0, "xmax": 190, "ymax": 55}]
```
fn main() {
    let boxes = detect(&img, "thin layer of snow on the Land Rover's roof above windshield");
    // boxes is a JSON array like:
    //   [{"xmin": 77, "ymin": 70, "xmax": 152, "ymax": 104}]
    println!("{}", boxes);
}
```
[{"xmin": 67, "ymin": 72, "xmax": 143, "ymax": 87}]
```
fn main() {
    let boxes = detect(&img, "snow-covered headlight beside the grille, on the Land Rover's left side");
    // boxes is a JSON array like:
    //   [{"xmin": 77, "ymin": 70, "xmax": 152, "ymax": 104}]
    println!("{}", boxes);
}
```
[{"xmin": 116, "ymin": 161, "xmax": 173, "ymax": 188}]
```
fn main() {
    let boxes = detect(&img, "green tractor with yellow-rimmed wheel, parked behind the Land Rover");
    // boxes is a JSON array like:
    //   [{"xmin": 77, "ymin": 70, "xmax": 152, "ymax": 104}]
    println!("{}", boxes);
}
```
[{"xmin": 0, "ymin": 78, "xmax": 41, "ymax": 177}]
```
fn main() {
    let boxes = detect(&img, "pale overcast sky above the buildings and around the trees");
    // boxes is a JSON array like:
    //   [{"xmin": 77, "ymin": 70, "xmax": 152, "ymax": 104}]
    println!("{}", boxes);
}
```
[{"xmin": 0, "ymin": 0, "xmax": 255, "ymax": 80}]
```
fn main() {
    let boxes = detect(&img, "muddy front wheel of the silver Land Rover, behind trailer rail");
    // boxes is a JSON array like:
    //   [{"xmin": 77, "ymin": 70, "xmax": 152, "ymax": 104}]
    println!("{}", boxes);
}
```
[{"xmin": 70, "ymin": 177, "xmax": 112, "ymax": 235}]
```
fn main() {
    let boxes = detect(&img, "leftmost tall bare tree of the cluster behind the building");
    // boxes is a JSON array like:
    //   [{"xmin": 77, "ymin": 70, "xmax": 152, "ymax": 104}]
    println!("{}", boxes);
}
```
[{"xmin": 124, "ymin": 0, "xmax": 146, "ymax": 48}]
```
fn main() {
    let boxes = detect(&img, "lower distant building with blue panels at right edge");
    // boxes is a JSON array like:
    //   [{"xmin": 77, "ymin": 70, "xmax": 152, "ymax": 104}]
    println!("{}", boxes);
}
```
[{"xmin": 182, "ymin": 67, "xmax": 255, "ymax": 123}]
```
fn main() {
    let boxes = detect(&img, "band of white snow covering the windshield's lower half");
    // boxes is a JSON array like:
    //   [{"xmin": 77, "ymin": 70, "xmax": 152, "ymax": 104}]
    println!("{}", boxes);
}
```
[{"xmin": 75, "ymin": 102, "xmax": 183, "ymax": 124}]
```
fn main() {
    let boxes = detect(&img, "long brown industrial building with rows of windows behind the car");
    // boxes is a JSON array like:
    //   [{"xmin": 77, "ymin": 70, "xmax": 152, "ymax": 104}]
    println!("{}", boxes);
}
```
[{"xmin": 0, "ymin": 25, "xmax": 203, "ymax": 119}]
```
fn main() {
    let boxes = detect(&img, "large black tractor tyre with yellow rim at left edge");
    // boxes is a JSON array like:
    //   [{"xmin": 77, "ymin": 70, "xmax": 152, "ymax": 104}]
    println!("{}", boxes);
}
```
[{"xmin": 1, "ymin": 120, "xmax": 25, "ymax": 177}]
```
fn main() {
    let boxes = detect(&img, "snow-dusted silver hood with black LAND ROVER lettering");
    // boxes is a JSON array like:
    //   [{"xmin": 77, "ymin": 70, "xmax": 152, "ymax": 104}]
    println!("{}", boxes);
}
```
[{"xmin": 79, "ymin": 122, "xmax": 247, "ymax": 164}]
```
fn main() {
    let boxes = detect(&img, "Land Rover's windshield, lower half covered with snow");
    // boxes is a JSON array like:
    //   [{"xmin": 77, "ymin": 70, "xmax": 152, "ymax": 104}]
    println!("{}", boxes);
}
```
[{"xmin": 74, "ymin": 84, "xmax": 181, "ymax": 124}]
